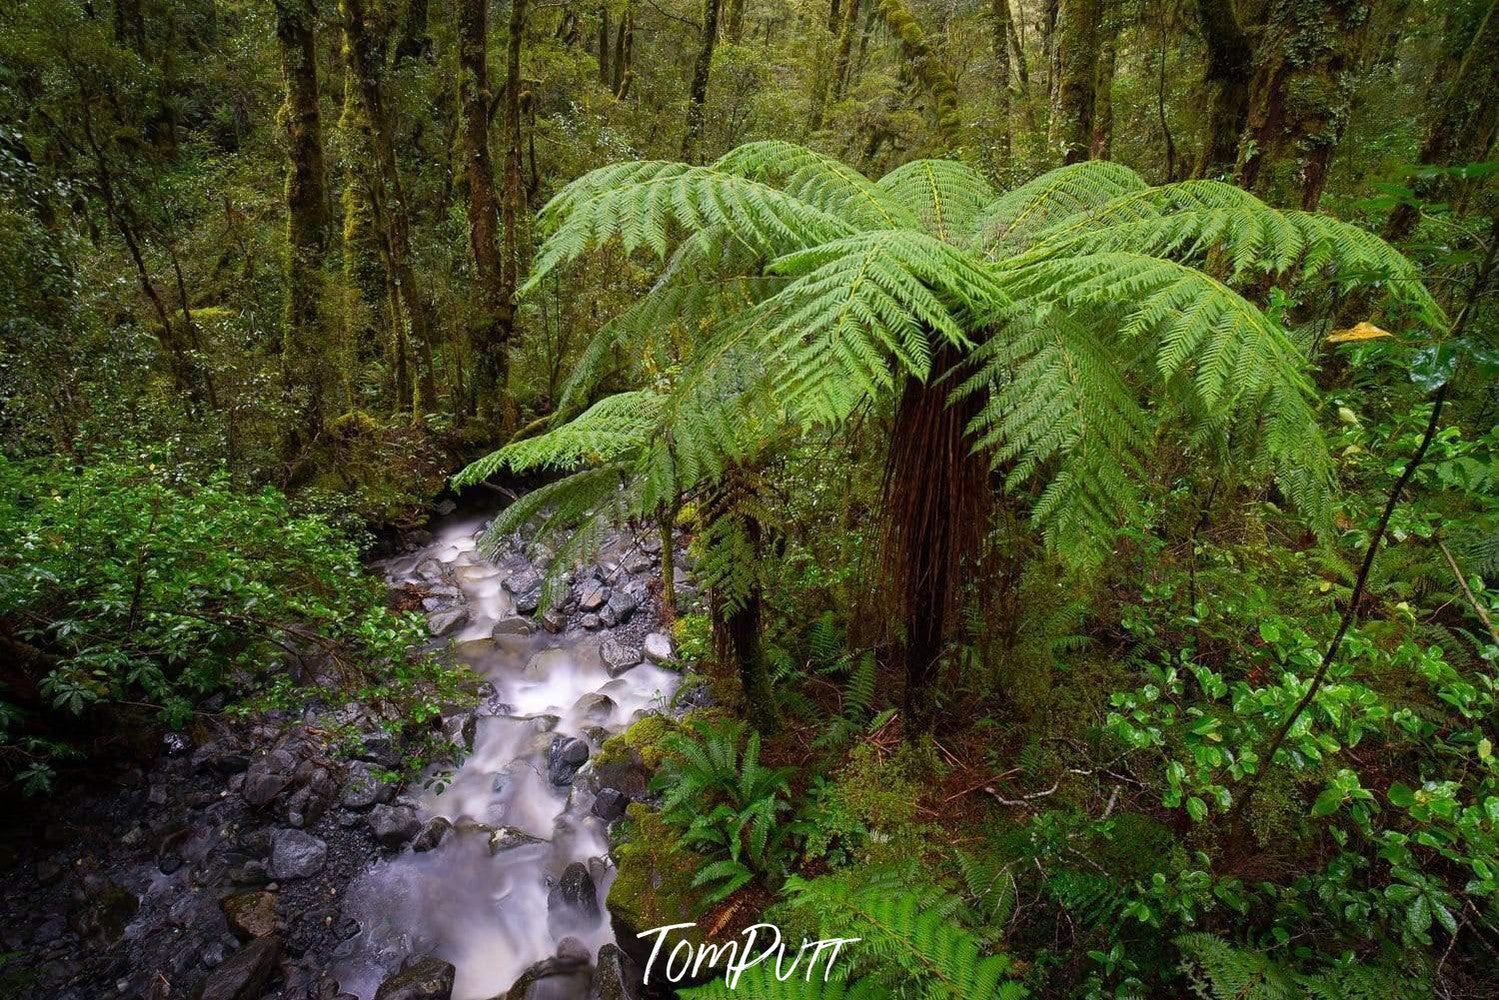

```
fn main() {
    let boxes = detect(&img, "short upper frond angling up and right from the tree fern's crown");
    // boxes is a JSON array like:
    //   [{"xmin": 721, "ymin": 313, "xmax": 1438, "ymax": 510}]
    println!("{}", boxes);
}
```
[{"xmin": 965, "ymin": 160, "xmax": 1147, "ymax": 261}]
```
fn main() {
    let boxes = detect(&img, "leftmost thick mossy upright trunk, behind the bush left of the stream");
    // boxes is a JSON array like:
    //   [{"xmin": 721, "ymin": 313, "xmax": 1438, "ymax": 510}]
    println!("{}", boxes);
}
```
[{"xmin": 276, "ymin": 0, "xmax": 333, "ymax": 454}]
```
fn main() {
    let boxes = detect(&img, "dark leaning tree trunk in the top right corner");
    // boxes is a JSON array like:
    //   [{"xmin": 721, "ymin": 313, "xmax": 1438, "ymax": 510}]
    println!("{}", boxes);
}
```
[{"xmin": 1384, "ymin": 1, "xmax": 1499, "ymax": 240}]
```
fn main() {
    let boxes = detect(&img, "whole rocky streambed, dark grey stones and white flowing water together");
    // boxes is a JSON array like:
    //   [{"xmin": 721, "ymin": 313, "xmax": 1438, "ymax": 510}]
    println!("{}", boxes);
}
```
[{"xmin": 0, "ymin": 503, "xmax": 701, "ymax": 1000}]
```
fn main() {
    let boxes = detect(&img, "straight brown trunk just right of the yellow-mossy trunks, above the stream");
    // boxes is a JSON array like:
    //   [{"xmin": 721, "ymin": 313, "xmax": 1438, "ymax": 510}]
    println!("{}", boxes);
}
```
[{"xmin": 457, "ymin": 0, "xmax": 515, "ymax": 417}]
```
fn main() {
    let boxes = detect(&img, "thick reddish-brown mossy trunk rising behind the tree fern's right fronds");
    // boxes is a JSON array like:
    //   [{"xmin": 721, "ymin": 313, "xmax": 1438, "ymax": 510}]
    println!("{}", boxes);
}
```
[{"xmin": 1237, "ymin": 0, "xmax": 1370, "ymax": 211}]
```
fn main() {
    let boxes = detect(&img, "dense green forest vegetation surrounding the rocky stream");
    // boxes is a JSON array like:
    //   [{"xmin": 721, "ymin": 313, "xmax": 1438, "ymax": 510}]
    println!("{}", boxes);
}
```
[{"xmin": 0, "ymin": 0, "xmax": 1499, "ymax": 997}]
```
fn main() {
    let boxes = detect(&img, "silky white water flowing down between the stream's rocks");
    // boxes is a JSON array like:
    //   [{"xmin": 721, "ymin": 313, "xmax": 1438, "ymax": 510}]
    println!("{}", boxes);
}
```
[{"xmin": 339, "ymin": 517, "xmax": 678, "ymax": 1000}]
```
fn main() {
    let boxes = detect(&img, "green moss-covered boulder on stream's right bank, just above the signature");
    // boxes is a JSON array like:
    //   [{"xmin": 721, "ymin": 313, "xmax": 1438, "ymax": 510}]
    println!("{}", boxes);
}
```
[{"xmin": 607, "ymin": 802, "xmax": 708, "ymax": 942}]
